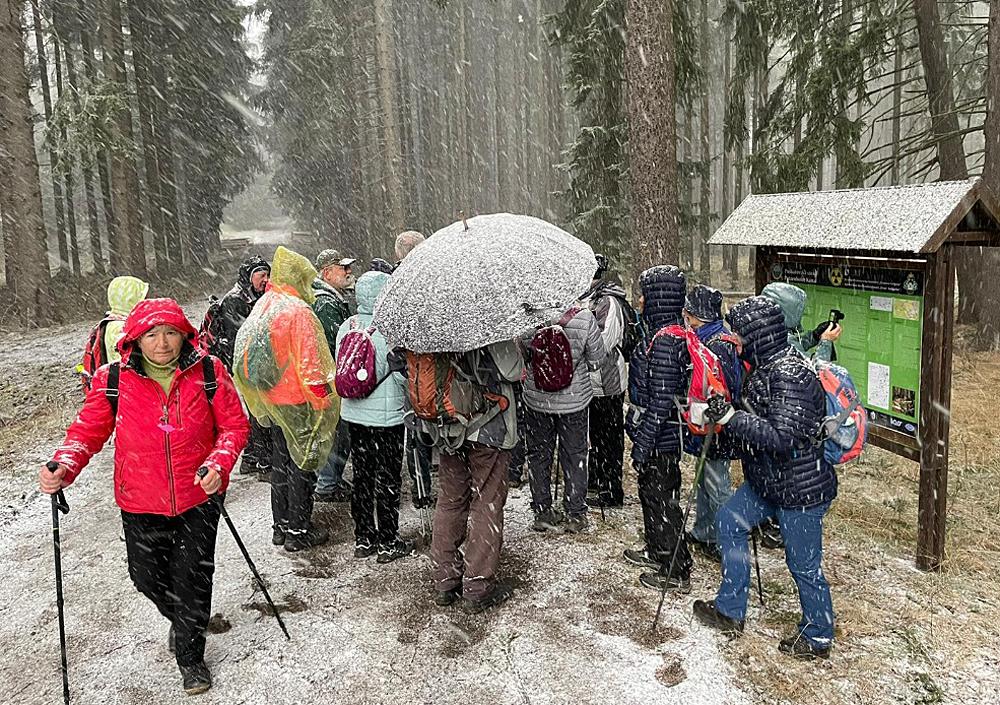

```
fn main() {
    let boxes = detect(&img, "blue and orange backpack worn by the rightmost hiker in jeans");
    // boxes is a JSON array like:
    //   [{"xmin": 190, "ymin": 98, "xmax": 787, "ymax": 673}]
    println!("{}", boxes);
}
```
[{"xmin": 813, "ymin": 361, "xmax": 868, "ymax": 465}]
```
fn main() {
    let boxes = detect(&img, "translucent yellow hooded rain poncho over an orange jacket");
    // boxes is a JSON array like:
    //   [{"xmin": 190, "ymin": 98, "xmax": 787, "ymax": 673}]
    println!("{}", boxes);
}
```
[{"xmin": 233, "ymin": 247, "xmax": 340, "ymax": 470}]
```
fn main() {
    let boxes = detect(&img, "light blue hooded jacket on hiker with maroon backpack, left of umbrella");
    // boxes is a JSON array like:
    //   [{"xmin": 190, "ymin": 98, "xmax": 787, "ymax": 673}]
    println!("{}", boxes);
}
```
[{"xmin": 337, "ymin": 272, "xmax": 407, "ymax": 427}]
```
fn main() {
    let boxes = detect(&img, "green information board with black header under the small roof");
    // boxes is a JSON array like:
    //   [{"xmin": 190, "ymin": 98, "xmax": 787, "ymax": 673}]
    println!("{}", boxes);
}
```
[{"xmin": 770, "ymin": 262, "xmax": 924, "ymax": 438}]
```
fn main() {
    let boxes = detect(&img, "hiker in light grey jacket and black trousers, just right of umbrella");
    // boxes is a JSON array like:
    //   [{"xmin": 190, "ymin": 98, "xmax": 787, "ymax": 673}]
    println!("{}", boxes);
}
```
[{"xmin": 583, "ymin": 255, "xmax": 631, "ymax": 507}]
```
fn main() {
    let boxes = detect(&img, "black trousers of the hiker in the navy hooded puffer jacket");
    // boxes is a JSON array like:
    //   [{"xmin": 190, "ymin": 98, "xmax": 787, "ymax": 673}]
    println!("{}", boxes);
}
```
[{"xmin": 636, "ymin": 453, "xmax": 693, "ymax": 578}]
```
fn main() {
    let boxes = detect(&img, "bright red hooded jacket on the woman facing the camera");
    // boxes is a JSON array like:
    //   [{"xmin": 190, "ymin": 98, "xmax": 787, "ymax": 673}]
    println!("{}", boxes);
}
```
[{"xmin": 53, "ymin": 299, "xmax": 250, "ymax": 516}]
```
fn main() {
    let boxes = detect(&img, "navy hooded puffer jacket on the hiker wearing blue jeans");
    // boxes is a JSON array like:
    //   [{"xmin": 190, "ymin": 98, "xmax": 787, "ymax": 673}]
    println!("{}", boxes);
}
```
[{"xmin": 723, "ymin": 296, "xmax": 837, "ymax": 508}]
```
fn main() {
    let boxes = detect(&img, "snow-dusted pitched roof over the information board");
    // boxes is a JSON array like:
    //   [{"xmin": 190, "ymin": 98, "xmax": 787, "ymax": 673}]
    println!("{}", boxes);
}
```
[{"xmin": 709, "ymin": 180, "xmax": 995, "ymax": 252}]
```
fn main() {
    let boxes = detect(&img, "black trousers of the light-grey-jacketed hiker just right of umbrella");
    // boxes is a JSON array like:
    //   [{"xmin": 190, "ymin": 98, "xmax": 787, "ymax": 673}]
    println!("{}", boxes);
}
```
[{"xmin": 588, "ymin": 394, "xmax": 625, "ymax": 507}]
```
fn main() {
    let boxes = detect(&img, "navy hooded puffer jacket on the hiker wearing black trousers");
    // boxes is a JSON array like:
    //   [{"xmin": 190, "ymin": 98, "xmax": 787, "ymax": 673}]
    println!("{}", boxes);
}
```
[{"xmin": 626, "ymin": 265, "xmax": 691, "ymax": 463}]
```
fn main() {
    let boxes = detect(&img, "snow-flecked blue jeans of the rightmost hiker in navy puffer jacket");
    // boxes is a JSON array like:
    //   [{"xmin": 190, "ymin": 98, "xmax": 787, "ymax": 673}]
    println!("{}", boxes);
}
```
[{"xmin": 715, "ymin": 482, "xmax": 833, "ymax": 648}]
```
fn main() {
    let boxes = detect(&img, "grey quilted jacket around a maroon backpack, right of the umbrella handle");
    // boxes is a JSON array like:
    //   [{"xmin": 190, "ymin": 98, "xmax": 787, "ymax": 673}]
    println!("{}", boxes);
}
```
[{"xmin": 521, "ymin": 308, "xmax": 608, "ymax": 414}]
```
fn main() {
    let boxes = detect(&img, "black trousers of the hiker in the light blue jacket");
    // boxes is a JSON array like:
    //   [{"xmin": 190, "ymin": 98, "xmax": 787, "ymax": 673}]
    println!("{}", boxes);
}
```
[{"xmin": 347, "ymin": 423, "xmax": 403, "ymax": 548}]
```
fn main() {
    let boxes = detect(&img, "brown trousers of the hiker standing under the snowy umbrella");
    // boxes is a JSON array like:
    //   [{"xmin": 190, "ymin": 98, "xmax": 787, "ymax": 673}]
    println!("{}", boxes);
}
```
[{"xmin": 431, "ymin": 443, "xmax": 510, "ymax": 601}]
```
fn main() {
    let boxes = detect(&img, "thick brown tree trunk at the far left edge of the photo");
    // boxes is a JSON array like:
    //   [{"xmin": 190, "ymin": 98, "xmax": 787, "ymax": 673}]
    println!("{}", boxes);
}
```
[{"xmin": 0, "ymin": 0, "xmax": 54, "ymax": 327}]
